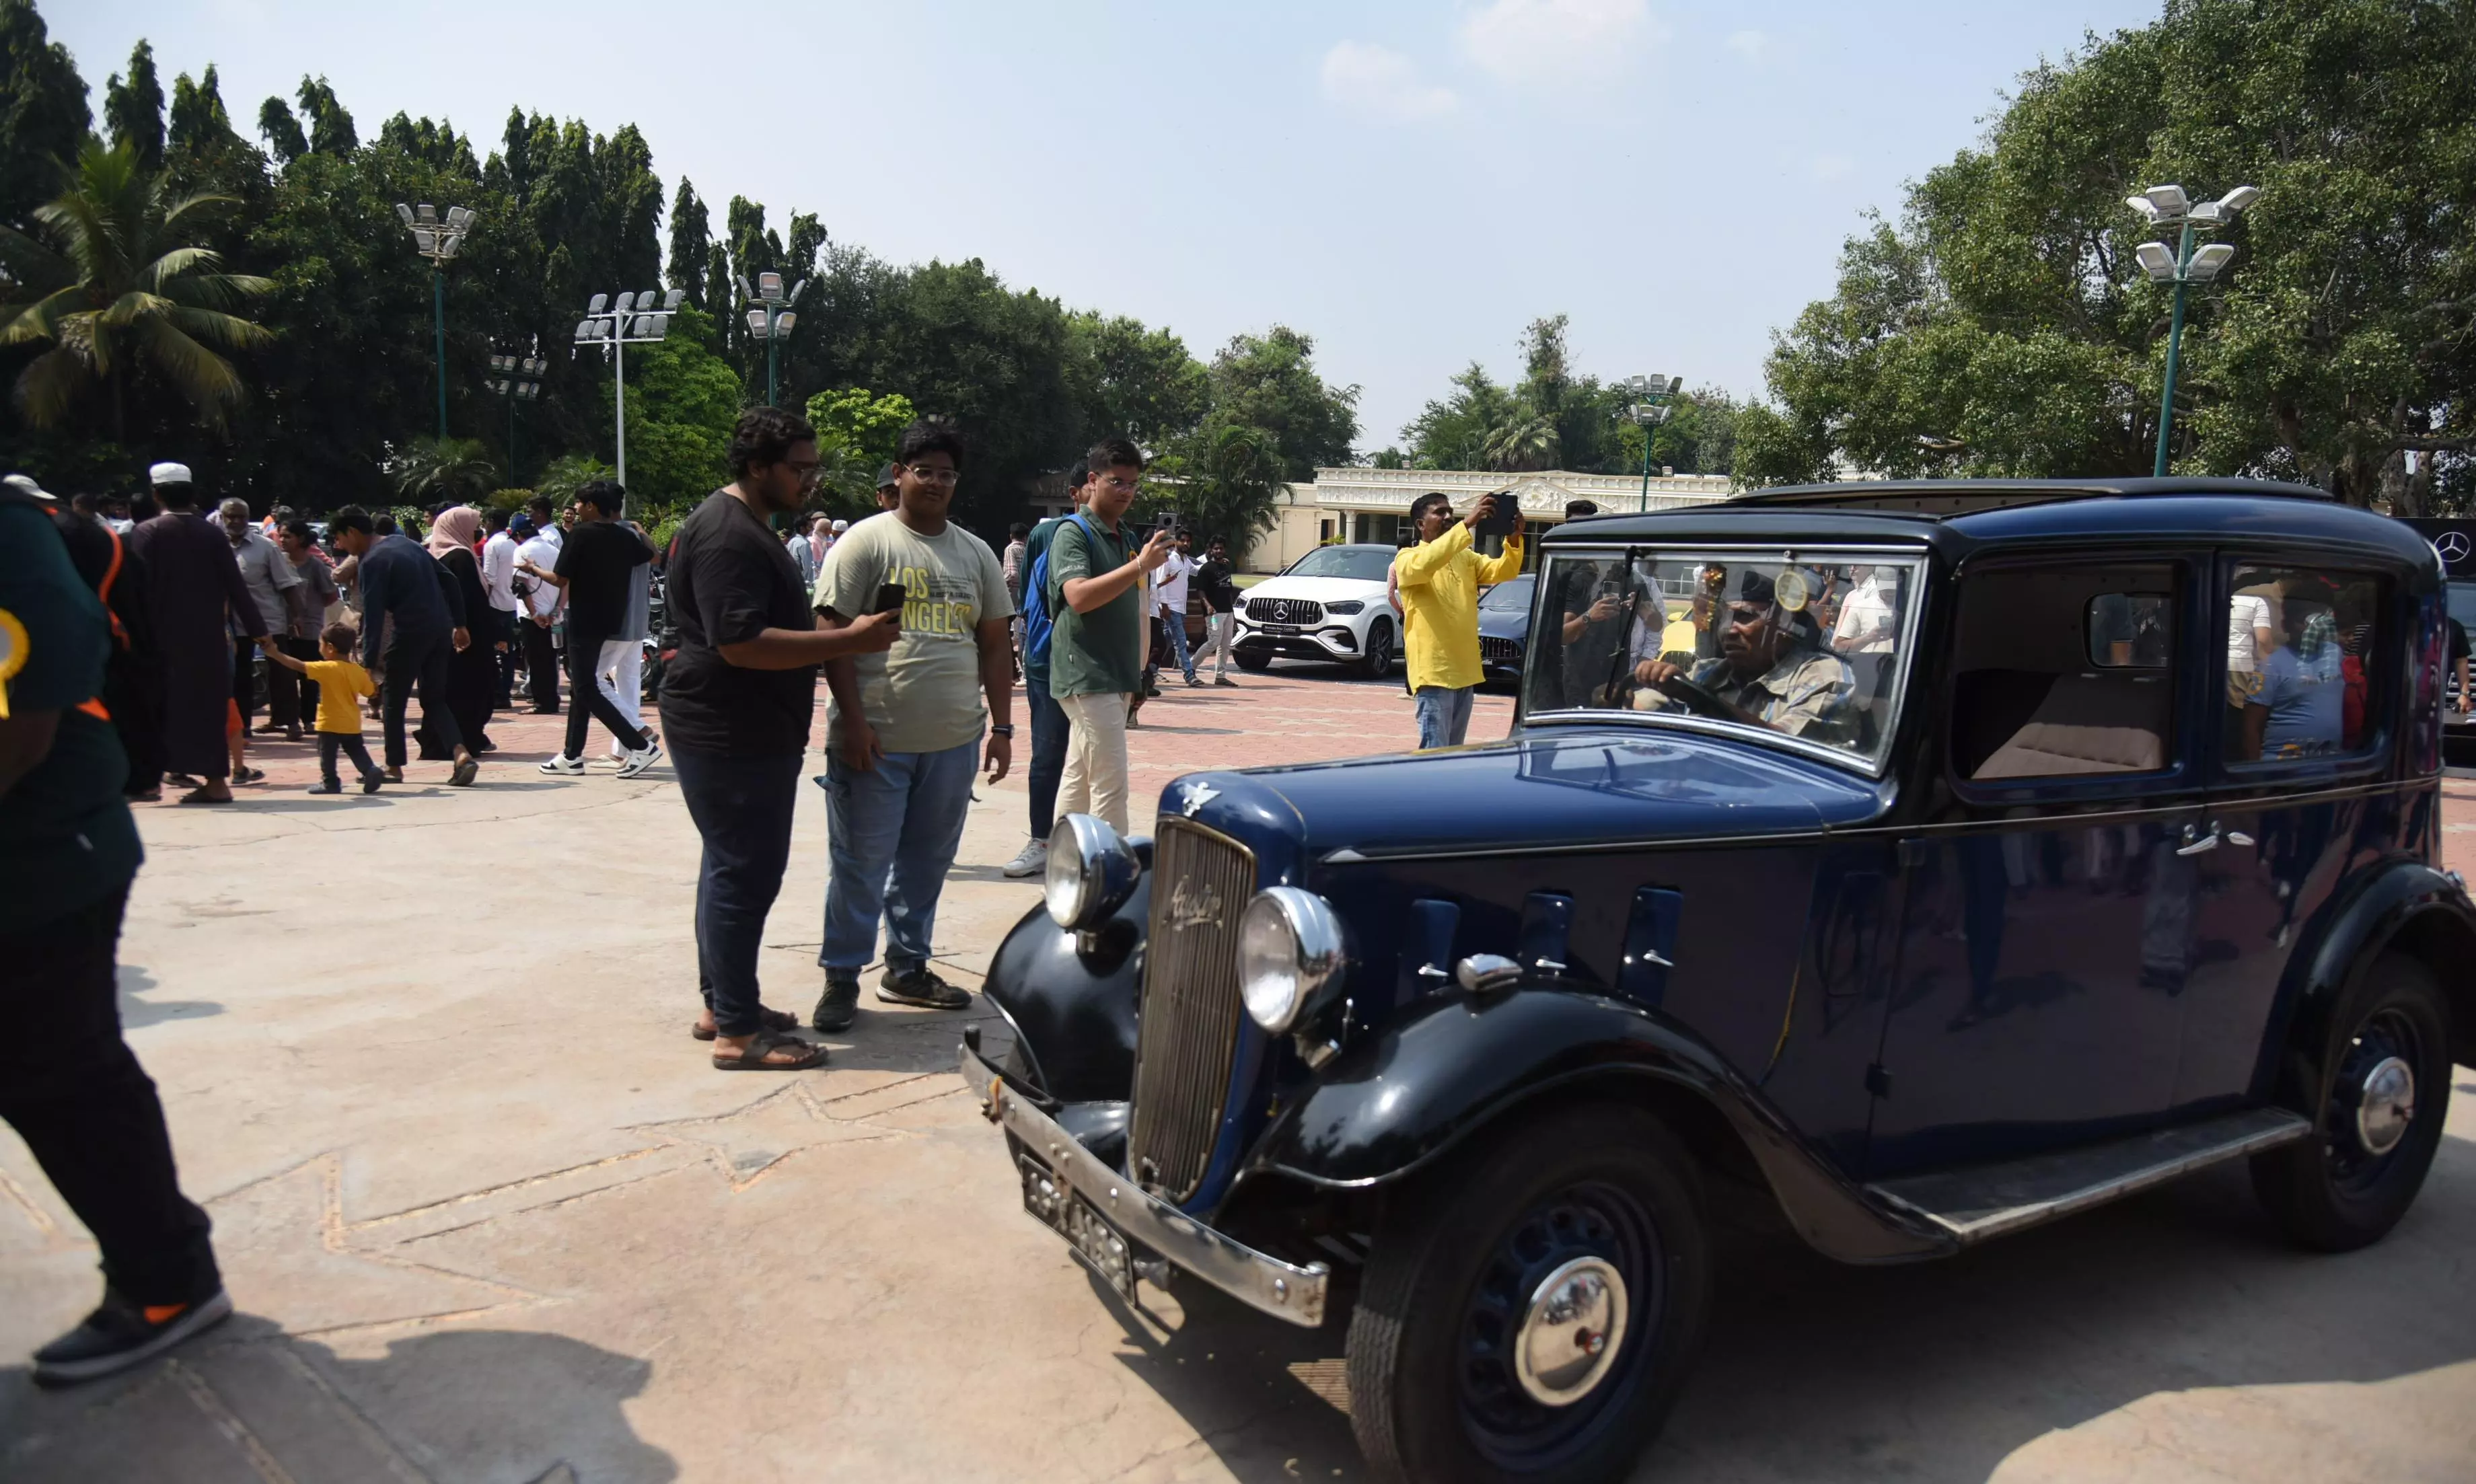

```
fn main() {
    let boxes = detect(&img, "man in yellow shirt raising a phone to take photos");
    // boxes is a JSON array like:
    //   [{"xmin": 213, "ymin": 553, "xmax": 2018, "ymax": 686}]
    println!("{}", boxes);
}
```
[{"xmin": 1394, "ymin": 493, "xmax": 1523, "ymax": 751}]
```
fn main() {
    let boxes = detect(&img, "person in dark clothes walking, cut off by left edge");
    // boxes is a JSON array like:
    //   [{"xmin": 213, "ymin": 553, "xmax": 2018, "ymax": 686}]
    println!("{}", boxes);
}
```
[{"xmin": 0, "ymin": 488, "xmax": 240, "ymax": 1385}]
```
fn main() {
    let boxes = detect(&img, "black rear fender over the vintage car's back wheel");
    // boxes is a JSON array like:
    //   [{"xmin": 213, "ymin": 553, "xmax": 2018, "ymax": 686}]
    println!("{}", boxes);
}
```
[{"xmin": 2255, "ymin": 860, "xmax": 2476, "ymax": 1085}]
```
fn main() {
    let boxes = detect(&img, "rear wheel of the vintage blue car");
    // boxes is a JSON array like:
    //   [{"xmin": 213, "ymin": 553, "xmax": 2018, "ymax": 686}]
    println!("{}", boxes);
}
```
[{"xmin": 2253, "ymin": 954, "xmax": 2451, "ymax": 1251}]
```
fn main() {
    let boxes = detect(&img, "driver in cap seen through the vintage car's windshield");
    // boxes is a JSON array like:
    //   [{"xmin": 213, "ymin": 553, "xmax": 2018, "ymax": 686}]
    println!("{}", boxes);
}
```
[{"xmin": 1634, "ymin": 567, "xmax": 1857, "ymax": 746}]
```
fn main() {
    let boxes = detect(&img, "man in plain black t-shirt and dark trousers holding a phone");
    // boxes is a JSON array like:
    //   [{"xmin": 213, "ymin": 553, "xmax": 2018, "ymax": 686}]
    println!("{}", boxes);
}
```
[{"xmin": 658, "ymin": 406, "xmax": 902, "ymax": 1073}]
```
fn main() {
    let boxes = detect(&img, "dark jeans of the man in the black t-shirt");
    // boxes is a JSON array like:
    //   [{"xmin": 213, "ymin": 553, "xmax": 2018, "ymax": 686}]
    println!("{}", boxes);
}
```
[{"xmin": 668, "ymin": 748, "xmax": 800, "ymax": 1035}]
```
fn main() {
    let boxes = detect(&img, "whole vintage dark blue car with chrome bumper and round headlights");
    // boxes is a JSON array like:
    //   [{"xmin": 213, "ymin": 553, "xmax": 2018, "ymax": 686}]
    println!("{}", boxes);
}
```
[{"xmin": 963, "ymin": 480, "xmax": 2476, "ymax": 1484}]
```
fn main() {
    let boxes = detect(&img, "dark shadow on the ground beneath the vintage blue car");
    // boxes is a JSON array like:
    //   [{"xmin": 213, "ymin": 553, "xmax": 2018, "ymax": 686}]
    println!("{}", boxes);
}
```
[{"xmin": 1092, "ymin": 1119, "xmax": 2476, "ymax": 1484}]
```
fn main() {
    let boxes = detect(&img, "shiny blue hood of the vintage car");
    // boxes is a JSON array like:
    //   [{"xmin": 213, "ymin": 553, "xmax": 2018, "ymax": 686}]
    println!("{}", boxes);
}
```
[{"xmin": 1161, "ymin": 726, "xmax": 1892, "ymax": 860}]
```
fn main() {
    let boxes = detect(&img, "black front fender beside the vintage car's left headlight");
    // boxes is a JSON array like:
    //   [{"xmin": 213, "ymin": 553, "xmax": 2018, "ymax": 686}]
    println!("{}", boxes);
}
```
[{"xmin": 983, "ymin": 872, "xmax": 1151, "ymax": 1103}]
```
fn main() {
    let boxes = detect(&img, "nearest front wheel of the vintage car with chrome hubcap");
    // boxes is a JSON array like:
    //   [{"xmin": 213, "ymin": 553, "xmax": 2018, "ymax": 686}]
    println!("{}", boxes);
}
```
[{"xmin": 1350, "ymin": 1105, "xmax": 1711, "ymax": 1484}]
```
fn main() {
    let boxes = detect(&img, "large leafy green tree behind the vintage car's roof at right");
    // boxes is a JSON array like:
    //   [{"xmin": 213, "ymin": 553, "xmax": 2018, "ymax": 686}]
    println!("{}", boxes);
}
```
[{"xmin": 1738, "ymin": 0, "xmax": 2476, "ymax": 511}]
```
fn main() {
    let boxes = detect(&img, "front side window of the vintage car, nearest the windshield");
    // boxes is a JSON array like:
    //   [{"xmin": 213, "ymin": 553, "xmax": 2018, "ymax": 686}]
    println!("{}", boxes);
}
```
[{"xmin": 1951, "ymin": 562, "xmax": 2181, "ymax": 783}]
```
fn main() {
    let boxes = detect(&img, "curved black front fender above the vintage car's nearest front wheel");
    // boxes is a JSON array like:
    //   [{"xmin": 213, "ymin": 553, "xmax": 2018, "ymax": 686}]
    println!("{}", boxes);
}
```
[{"xmin": 1248, "ymin": 984, "xmax": 1956, "ymax": 1263}]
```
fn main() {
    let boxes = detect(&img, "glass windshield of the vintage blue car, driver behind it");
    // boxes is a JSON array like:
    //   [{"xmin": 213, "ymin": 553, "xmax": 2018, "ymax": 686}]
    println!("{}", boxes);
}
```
[{"xmin": 1523, "ymin": 548, "xmax": 1919, "ymax": 763}]
